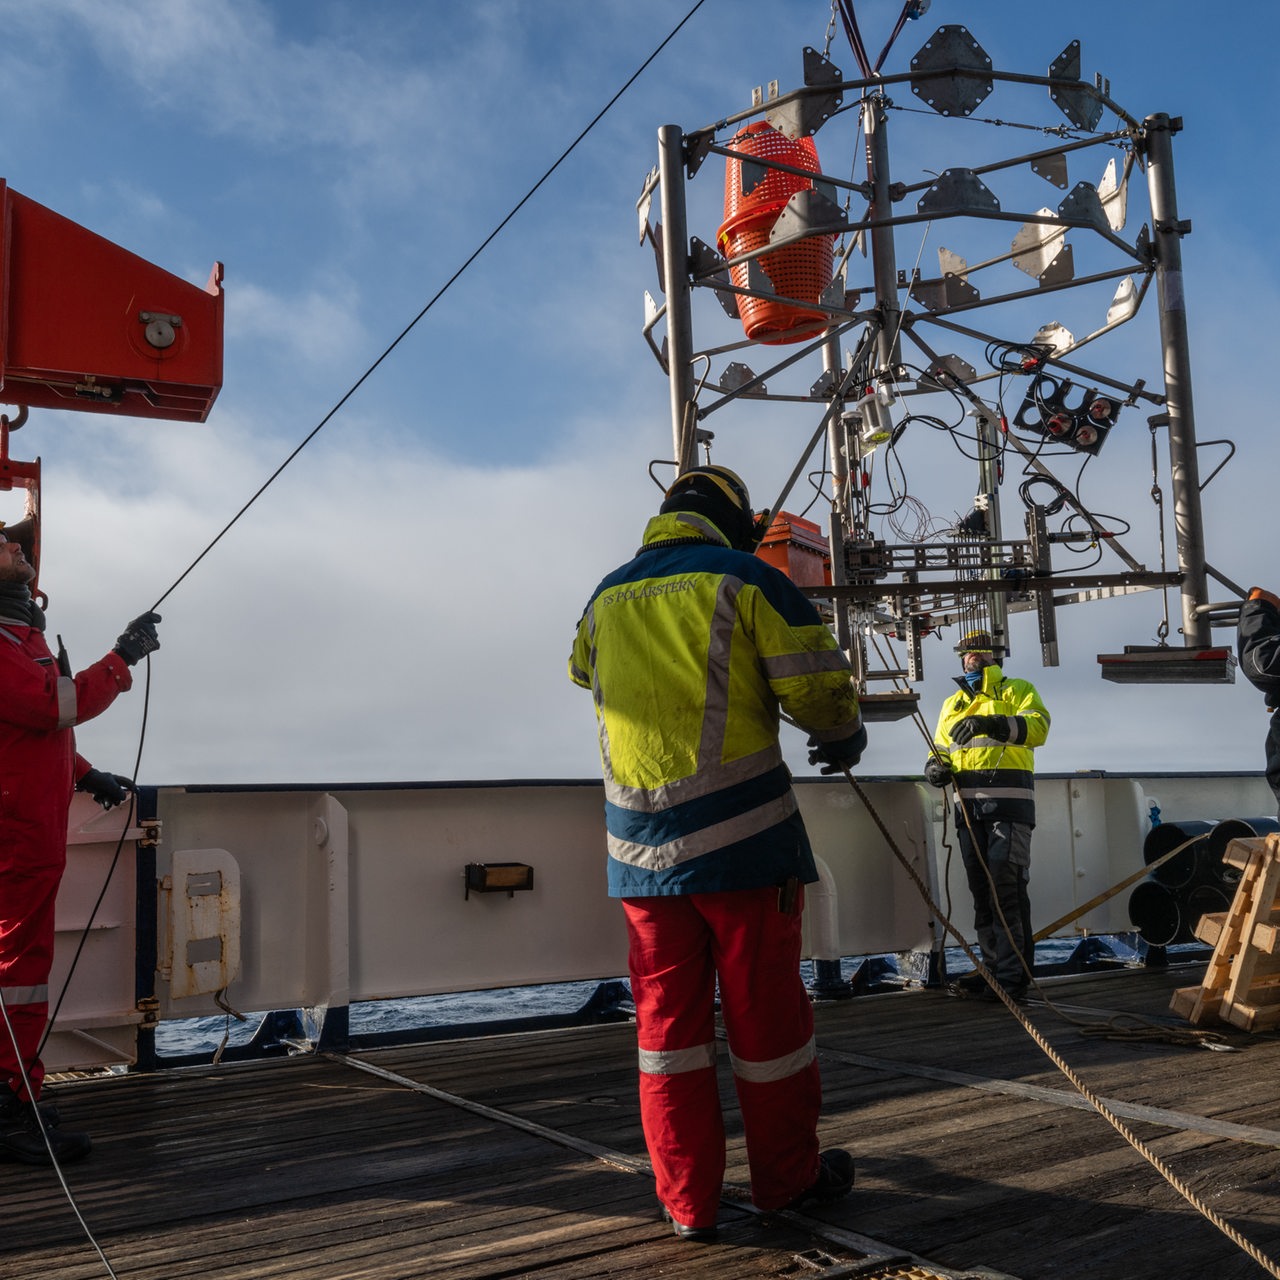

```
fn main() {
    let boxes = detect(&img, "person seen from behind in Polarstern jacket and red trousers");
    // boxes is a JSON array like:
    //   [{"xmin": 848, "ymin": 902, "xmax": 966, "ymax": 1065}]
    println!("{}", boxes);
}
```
[{"xmin": 568, "ymin": 466, "xmax": 867, "ymax": 1242}]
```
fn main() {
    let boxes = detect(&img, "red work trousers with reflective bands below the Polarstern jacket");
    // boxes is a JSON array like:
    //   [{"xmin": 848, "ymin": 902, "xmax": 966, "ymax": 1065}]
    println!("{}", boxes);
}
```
[{"xmin": 622, "ymin": 887, "xmax": 822, "ymax": 1226}]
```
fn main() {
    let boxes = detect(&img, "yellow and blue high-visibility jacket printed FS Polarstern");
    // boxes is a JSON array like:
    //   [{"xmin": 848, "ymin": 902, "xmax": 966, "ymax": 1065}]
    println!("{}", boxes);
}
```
[{"xmin": 568, "ymin": 512, "xmax": 865, "ymax": 897}]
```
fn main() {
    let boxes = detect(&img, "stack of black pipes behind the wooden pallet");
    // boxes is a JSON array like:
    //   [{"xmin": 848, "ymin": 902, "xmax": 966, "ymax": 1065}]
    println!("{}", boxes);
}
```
[{"xmin": 1129, "ymin": 818, "xmax": 1280, "ymax": 947}]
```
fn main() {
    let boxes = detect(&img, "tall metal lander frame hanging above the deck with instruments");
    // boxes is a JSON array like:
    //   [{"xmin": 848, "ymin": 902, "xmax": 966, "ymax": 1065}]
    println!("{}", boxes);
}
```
[{"xmin": 637, "ymin": 17, "xmax": 1244, "ymax": 719}]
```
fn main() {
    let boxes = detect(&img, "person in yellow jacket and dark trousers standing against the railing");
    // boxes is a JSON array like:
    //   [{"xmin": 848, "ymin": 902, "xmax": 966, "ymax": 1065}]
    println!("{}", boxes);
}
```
[{"xmin": 924, "ymin": 631, "xmax": 1050, "ymax": 1000}]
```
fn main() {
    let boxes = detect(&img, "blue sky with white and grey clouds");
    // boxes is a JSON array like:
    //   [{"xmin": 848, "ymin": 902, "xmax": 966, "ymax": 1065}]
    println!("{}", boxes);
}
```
[{"xmin": 0, "ymin": 0, "xmax": 1280, "ymax": 783}]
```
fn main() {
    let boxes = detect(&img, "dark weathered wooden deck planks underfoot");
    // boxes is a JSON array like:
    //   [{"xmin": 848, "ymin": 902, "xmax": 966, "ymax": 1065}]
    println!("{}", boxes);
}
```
[{"xmin": 0, "ymin": 973, "xmax": 1280, "ymax": 1280}]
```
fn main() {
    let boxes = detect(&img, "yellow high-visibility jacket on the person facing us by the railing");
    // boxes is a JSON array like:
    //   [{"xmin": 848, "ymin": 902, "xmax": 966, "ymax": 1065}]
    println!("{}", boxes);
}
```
[{"xmin": 933, "ymin": 666, "xmax": 1050, "ymax": 826}]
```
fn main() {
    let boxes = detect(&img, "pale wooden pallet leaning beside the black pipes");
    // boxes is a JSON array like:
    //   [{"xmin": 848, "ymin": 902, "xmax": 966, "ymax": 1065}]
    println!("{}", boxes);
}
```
[{"xmin": 1169, "ymin": 833, "xmax": 1280, "ymax": 1032}]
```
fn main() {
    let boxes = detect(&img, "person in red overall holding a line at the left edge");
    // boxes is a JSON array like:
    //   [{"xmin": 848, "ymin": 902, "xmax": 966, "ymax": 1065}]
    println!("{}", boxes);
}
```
[{"xmin": 0, "ymin": 530, "xmax": 160, "ymax": 1165}]
